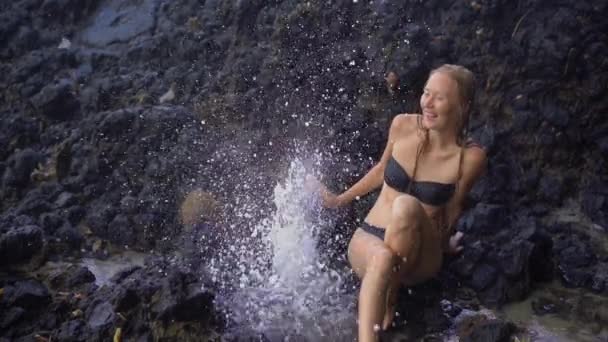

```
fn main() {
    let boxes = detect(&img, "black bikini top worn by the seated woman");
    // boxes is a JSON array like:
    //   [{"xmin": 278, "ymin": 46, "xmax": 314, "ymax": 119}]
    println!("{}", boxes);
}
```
[{"xmin": 384, "ymin": 156, "xmax": 456, "ymax": 206}]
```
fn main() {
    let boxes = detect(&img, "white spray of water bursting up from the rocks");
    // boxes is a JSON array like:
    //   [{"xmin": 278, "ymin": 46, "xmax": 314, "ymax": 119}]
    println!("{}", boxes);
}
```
[{"xmin": 212, "ymin": 159, "xmax": 355, "ymax": 341}]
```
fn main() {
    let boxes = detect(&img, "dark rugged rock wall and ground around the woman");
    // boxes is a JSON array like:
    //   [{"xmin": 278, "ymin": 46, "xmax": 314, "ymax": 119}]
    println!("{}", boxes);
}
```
[{"xmin": 0, "ymin": 0, "xmax": 608, "ymax": 340}]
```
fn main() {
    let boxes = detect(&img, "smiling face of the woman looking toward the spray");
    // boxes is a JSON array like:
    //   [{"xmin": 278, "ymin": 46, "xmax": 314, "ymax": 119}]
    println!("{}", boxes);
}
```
[{"xmin": 420, "ymin": 72, "xmax": 460, "ymax": 131}]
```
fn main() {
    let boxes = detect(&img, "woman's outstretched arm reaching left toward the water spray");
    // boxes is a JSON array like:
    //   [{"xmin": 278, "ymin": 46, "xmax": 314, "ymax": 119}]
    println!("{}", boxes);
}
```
[{"xmin": 323, "ymin": 114, "xmax": 412, "ymax": 207}]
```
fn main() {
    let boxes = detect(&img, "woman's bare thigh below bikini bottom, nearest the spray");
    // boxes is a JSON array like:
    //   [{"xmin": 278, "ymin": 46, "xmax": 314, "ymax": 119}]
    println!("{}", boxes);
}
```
[{"xmin": 348, "ymin": 228, "xmax": 387, "ymax": 279}]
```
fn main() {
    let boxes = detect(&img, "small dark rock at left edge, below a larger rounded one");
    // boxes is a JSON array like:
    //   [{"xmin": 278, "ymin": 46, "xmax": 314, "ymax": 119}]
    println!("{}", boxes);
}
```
[{"xmin": 0, "ymin": 280, "xmax": 51, "ymax": 310}]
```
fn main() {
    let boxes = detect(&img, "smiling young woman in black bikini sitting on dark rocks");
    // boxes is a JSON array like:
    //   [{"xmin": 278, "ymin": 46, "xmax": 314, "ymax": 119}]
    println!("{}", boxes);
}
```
[{"xmin": 322, "ymin": 64, "xmax": 486, "ymax": 342}]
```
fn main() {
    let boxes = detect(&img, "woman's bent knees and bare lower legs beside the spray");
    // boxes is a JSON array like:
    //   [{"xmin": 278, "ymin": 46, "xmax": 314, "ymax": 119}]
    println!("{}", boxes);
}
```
[{"xmin": 359, "ymin": 195, "xmax": 430, "ymax": 341}]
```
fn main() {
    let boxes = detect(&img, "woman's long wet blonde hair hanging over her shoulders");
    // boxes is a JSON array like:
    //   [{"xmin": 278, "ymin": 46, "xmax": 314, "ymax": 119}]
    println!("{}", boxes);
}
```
[{"xmin": 408, "ymin": 64, "xmax": 475, "ymax": 243}]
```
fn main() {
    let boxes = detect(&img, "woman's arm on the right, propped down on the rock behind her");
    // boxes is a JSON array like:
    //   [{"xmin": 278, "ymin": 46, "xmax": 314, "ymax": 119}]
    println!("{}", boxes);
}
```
[{"xmin": 442, "ymin": 146, "xmax": 487, "ymax": 251}]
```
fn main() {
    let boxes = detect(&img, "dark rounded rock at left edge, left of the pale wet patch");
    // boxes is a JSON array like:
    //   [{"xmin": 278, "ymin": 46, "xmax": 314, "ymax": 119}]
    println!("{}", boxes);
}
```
[{"xmin": 0, "ymin": 226, "xmax": 43, "ymax": 266}]
